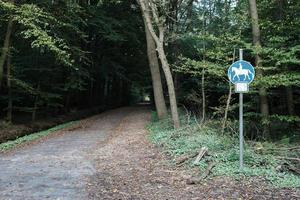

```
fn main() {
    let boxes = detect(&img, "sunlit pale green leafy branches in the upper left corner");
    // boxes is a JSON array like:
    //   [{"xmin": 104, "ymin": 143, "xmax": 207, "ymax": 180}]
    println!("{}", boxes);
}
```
[{"xmin": 0, "ymin": 1, "xmax": 73, "ymax": 66}]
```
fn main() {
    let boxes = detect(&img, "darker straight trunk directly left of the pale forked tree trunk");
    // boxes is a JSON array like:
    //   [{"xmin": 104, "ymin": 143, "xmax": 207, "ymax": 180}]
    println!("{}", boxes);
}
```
[{"xmin": 144, "ymin": 21, "xmax": 167, "ymax": 119}]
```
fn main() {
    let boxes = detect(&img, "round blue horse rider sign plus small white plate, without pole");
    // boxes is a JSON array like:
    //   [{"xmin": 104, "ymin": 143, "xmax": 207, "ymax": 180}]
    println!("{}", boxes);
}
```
[{"xmin": 228, "ymin": 60, "xmax": 255, "ymax": 93}]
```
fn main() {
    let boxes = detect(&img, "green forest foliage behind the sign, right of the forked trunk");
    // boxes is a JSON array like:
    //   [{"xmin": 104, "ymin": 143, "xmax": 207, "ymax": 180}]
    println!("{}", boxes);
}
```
[{"xmin": 169, "ymin": 0, "xmax": 300, "ymax": 139}]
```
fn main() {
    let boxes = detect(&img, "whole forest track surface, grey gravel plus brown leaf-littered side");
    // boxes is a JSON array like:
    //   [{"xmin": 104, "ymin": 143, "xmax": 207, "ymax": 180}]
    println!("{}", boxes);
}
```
[{"xmin": 0, "ymin": 107, "xmax": 300, "ymax": 200}]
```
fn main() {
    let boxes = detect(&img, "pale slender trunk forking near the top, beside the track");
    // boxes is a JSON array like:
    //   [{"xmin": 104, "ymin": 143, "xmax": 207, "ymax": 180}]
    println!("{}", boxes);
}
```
[{"xmin": 138, "ymin": 0, "xmax": 180, "ymax": 128}]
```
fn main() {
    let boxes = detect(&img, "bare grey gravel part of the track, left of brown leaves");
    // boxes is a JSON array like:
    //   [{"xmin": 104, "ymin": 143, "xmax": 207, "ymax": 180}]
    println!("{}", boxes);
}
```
[{"xmin": 0, "ymin": 108, "xmax": 133, "ymax": 200}]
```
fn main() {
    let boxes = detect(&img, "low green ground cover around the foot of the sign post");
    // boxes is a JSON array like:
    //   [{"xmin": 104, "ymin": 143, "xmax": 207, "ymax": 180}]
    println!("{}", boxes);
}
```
[{"xmin": 147, "ymin": 112, "xmax": 300, "ymax": 188}]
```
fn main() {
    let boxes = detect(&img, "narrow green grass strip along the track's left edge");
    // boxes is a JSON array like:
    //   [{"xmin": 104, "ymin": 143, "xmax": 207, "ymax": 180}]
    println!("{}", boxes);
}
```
[{"xmin": 0, "ymin": 121, "xmax": 77, "ymax": 152}]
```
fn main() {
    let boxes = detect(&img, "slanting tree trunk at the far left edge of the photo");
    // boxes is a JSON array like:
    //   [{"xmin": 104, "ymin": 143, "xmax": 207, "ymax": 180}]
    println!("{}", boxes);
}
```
[{"xmin": 0, "ymin": 0, "xmax": 14, "ymax": 88}]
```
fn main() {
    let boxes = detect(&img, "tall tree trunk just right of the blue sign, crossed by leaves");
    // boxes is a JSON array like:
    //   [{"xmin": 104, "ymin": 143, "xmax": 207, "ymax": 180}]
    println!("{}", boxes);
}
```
[{"xmin": 249, "ymin": 0, "xmax": 270, "ymax": 138}]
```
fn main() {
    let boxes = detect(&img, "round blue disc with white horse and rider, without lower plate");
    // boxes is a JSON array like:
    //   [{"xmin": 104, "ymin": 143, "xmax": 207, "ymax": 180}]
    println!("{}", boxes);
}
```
[{"xmin": 228, "ymin": 60, "xmax": 255, "ymax": 84}]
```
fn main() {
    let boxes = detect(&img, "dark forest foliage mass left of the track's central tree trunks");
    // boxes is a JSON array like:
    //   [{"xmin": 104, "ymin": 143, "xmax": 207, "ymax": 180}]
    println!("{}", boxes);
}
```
[{"xmin": 0, "ymin": 0, "xmax": 151, "ymax": 125}]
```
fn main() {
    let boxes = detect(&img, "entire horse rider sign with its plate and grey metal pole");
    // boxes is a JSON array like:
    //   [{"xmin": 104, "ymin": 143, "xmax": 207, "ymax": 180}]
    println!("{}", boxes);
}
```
[{"xmin": 228, "ymin": 49, "xmax": 255, "ymax": 170}]
